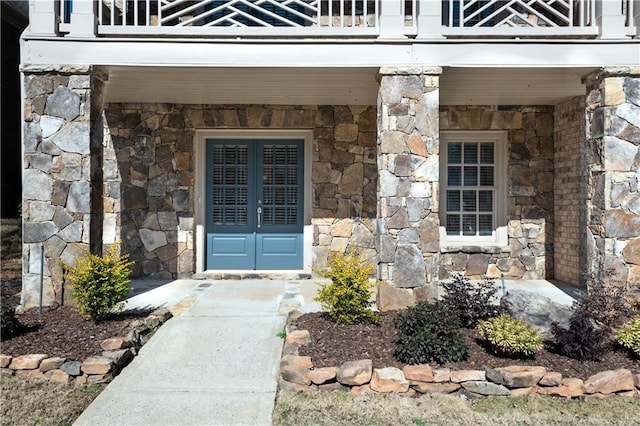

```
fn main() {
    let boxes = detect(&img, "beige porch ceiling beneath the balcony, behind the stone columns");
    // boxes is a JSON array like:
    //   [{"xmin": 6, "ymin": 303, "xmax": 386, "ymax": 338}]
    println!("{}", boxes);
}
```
[{"xmin": 105, "ymin": 66, "xmax": 595, "ymax": 105}]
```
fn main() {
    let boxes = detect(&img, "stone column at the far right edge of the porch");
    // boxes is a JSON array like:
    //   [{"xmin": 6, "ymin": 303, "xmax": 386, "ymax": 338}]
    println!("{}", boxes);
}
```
[{"xmin": 583, "ymin": 67, "xmax": 640, "ymax": 297}]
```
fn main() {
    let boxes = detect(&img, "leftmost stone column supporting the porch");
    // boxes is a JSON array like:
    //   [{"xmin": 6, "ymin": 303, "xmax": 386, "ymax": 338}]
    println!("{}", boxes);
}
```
[{"xmin": 21, "ymin": 66, "xmax": 104, "ymax": 309}]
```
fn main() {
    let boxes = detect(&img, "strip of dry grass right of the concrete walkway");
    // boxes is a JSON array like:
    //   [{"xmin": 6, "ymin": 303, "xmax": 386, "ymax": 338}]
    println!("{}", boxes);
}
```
[{"xmin": 273, "ymin": 392, "xmax": 640, "ymax": 426}]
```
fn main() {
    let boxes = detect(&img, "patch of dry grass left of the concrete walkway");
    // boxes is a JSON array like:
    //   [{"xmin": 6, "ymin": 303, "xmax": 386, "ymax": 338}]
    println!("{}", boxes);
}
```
[{"xmin": 0, "ymin": 377, "xmax": 104, "ymax": 426}]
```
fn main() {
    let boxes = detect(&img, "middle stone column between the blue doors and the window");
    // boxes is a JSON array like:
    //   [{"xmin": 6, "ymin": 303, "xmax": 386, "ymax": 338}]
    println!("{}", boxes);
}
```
[{"xmin": 376, "ymin": 67, "xmax": 441, "ymax": 310}]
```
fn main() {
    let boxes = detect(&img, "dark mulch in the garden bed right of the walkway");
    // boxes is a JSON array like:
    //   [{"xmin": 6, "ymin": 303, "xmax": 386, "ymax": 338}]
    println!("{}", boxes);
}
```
[{"xmin": 291, "ymin": 313, "xmax": 640, "ymax": 379}]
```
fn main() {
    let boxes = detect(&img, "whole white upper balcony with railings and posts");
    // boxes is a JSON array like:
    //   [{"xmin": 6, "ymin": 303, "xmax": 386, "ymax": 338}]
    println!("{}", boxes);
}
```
[{"xmin": 30, "ymin": 0, "xmax": 640, "ymax": 42}]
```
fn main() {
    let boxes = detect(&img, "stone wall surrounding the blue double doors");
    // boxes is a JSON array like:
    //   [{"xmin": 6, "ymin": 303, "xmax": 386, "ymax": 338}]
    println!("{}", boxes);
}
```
[{"xmin": 104, "ymin": 104, "xmax": 377, "ymax": 278}]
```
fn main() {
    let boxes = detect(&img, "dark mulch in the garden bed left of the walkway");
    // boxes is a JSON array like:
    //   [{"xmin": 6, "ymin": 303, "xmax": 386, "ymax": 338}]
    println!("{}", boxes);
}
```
[{"xmin": 0, "ymin": 287, "xmax": 149, "ymax": 361}]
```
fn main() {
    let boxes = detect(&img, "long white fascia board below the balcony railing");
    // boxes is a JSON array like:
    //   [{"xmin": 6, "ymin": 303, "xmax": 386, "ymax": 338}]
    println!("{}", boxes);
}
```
[{"xmin": 22, "ymin": 39, "xmax": 640, "ymax": 68}]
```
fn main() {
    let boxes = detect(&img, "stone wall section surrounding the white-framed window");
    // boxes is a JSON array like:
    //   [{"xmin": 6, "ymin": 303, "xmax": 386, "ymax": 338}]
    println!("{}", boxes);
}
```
[{"xmin": 440, "ymin": 106, "xmax": 554, "ymax": 279}]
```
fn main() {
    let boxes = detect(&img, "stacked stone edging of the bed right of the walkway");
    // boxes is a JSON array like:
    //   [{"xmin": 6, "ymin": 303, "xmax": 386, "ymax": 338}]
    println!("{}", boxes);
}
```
[{"xmin": 279, "ymin": 330, "xmax": 640, "ymax": 398}]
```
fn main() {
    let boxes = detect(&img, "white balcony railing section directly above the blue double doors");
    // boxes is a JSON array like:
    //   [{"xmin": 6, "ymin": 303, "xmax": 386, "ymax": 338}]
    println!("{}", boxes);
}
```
[{"xmin": 97, "ymin": 0, "xmax": 380, "ymax": 37}]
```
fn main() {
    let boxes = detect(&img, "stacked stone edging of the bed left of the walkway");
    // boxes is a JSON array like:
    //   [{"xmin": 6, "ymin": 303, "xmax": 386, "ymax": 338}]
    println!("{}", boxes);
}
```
[{"xmin": 0, "ymin": 308, "xmax": 173, "ymax": 385}]
